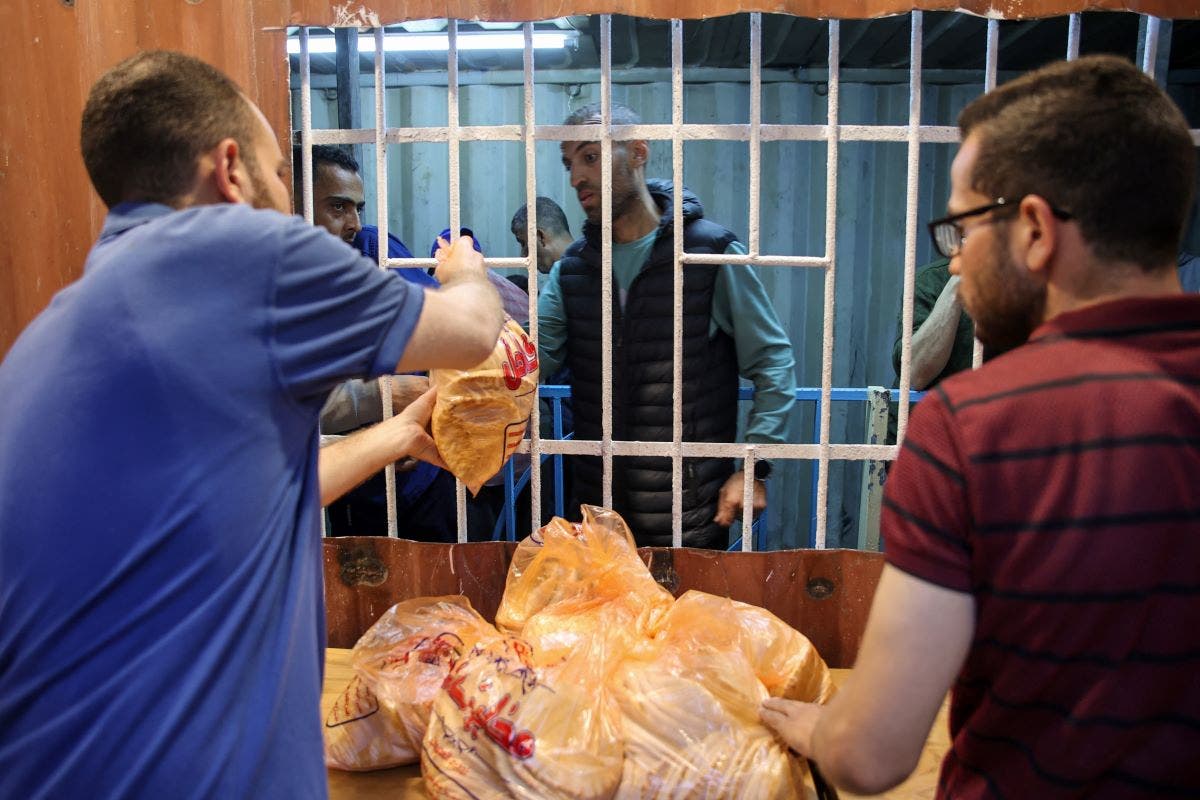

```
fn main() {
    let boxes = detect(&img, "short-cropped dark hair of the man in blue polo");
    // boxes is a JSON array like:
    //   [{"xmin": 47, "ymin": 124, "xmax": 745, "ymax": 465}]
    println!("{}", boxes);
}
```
[{"xmin": 79, "ymin": 50, "xmax": 260, "ymax": 207}]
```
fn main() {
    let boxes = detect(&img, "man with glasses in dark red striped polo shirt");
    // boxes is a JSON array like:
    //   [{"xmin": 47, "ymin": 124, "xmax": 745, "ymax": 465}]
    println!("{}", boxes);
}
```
[{"xmin": 763, "ymin": 56, "xmax": 1200, "ymax": 798}]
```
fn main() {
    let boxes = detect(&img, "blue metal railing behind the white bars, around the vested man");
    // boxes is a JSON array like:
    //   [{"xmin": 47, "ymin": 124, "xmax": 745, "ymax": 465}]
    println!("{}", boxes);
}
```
[{"xmin": 492, "ymin": 385, "xmax": 925, "ymax": 551}]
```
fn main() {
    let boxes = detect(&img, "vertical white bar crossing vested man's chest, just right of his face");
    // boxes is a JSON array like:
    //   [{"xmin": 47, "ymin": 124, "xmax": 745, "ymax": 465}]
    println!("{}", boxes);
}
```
[{"xmin": 671, "ymin": 19, "xmax": 684, "ymax": 547}]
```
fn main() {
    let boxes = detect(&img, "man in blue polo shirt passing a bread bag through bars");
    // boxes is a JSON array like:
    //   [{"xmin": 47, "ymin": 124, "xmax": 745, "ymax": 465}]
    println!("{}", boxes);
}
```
[{"xmin": 0, "ymin": 53, "xmax": 502, "ymax": 799}]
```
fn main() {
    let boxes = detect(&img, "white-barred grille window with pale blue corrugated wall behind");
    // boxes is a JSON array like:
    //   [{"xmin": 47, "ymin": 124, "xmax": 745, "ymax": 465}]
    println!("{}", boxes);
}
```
[{"xmin": 289, "ymin": 11, "xmax": 1200, "ymax": 551}]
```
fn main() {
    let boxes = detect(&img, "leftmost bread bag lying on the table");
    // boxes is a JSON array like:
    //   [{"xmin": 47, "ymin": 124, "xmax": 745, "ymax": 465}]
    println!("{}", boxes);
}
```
[{"xmin": 325, "ymin": 595, "xmax": 499, "ymax": 770}]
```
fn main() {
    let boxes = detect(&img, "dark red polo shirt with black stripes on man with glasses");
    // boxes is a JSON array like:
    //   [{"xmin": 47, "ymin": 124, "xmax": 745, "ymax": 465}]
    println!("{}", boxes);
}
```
[{"xmin": 883, "ymin": 295, "xmax": 1200, "ymax": 799}]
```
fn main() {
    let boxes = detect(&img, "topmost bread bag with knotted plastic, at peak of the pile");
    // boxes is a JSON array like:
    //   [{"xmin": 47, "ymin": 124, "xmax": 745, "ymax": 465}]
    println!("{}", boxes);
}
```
[{"xmin": 496, "ymin": 505, "xmax": 672, "ymax": 636}]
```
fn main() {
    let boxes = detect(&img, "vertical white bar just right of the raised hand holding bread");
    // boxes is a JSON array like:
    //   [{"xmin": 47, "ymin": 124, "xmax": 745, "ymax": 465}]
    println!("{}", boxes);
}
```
[{"xmin": 525, "ymin": 23, "xmax": 544, "ymax": 539}]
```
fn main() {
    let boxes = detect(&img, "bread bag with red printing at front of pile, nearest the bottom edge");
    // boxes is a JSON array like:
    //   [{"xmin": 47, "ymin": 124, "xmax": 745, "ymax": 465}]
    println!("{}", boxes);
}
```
[{"xmin": 421, "ymin": 637, "xmax": 623, "ymax": 800}]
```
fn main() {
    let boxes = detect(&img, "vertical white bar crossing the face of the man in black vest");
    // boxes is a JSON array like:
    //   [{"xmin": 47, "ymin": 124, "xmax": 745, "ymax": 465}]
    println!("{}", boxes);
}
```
[{"xmin": 600, "ymin": 14, "xmax": 612, "ymax": 509}]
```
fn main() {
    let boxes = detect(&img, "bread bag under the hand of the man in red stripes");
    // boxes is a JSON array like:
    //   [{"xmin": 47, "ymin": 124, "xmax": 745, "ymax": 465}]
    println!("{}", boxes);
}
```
[{"xmin": 611, "ymin": 591, "xmax": 833, "ymax": 800}]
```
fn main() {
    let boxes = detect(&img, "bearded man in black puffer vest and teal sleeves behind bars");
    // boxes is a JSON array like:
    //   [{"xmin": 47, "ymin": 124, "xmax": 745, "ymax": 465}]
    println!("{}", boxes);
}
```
[{"xmin": 538, "ymin": 103, "xmax": 796, "ymax": 549}]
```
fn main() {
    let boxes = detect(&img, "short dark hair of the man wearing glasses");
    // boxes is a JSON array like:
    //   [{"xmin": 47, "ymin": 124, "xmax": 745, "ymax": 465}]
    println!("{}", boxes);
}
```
[{"xmin": 959, "ymin": 55, "xmax": 1195, "ymax": 271}]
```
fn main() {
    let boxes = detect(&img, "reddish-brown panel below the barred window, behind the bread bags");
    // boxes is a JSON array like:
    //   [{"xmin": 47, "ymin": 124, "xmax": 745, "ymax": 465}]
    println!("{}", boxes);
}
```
[{"xmin": 325, "ymin": 536, "xmax": 883, "ymax": 667}]
